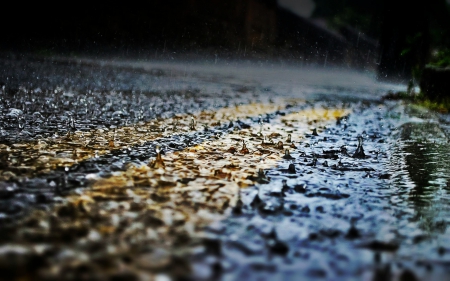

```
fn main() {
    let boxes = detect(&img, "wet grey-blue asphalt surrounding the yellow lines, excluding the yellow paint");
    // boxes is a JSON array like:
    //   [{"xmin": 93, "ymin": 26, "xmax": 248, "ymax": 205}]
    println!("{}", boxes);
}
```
[{"xmin": 0, "ymin": 55, "xmax": 450, "ymax": 280}]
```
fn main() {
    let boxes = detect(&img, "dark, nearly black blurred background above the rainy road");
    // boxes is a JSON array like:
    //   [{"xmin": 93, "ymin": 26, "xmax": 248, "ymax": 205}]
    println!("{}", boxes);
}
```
[{"xmin": 0, "ymin": 0, "xmax": 450, "ymax": 82}]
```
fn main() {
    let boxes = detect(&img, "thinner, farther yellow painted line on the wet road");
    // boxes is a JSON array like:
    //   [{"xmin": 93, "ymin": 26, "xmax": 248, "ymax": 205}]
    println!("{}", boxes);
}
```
[{"xmin": 0, "ymin": 100, "xmax": 286, "ymax": 181}]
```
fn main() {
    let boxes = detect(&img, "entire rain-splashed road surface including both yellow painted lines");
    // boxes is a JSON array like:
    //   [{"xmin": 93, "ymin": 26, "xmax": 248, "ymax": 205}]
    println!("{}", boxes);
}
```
[{"xmin": 0, "ymin": 55, "xmax": 450, "ymax": 280}]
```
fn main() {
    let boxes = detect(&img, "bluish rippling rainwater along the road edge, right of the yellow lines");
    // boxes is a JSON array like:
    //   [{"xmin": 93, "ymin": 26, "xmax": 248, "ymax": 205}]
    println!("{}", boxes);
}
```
[{"xmin": 194, "ymin": 105, "xmax": 450, "ymax": 280}]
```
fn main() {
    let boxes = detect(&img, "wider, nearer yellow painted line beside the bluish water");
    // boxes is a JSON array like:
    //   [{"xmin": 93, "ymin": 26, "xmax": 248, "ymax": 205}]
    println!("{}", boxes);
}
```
[{"xmin": 7, "ymin": 104, "xmax": 348, "ymax": 277}]
